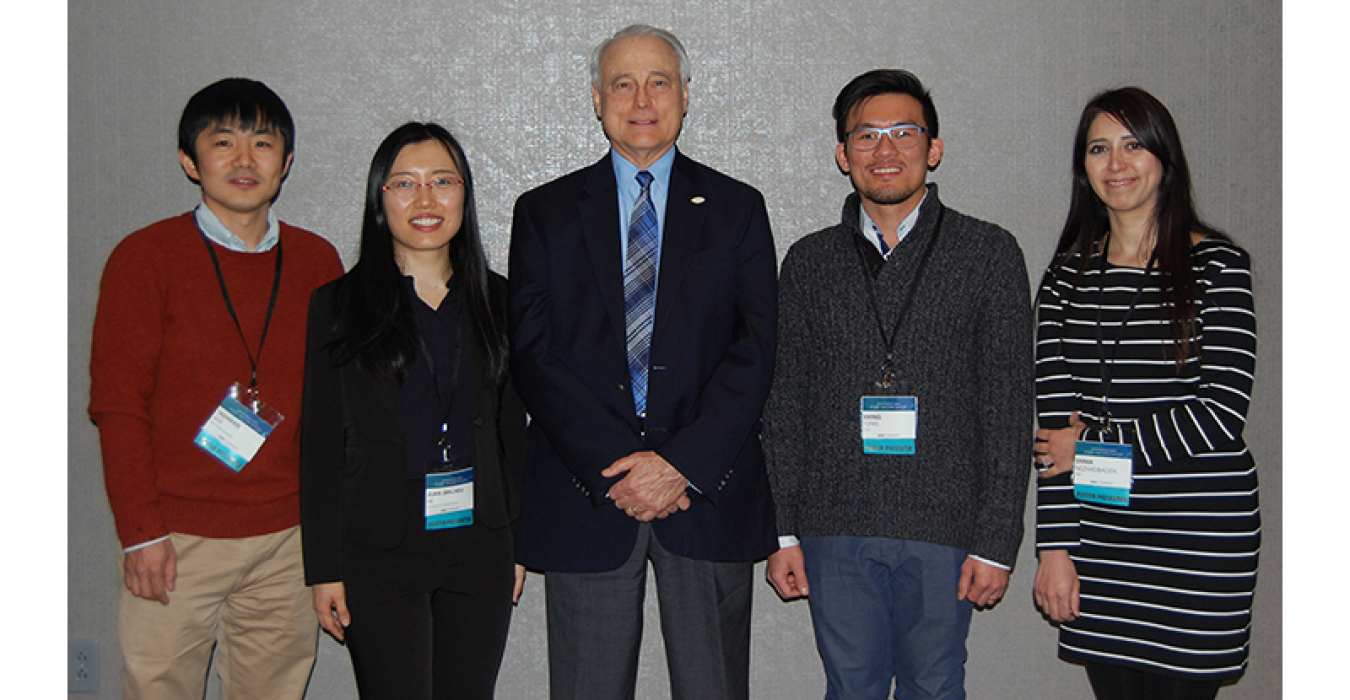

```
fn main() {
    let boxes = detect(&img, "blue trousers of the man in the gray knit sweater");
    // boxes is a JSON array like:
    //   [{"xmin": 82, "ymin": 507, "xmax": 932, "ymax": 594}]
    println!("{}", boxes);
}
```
[{"xmin": 802, "ymin": 537, "xmax": 972, "ymax": 700}]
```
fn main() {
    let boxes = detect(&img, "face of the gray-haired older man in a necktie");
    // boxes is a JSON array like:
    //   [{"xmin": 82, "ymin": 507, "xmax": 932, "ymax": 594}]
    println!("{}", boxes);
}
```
[{"xmin": 591, "ymin": 36, "xmax": 689, "ymax": 169}]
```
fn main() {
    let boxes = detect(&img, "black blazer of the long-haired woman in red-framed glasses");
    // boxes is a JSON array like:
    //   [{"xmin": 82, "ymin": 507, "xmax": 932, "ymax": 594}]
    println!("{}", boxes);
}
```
[{"xmin": 300, "ymin": 274, "xmax": 525, "ymax": 585}]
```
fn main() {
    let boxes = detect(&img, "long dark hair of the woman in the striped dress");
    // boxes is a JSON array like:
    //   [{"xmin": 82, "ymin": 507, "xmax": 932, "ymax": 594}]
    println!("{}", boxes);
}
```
[{"xmin": 1052, "ymin": 86, "xmax": 1229, "ymax": 367}]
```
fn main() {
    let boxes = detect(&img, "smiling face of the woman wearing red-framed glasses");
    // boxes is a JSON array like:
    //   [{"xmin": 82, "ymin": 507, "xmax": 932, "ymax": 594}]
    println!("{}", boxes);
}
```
[{"xmin": 383, "ymin": 139, "xmax": 464, "ymax": 262}]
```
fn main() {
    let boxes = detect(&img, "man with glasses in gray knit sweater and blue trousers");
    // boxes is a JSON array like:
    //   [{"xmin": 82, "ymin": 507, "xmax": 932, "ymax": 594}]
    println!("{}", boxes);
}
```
[{"xmin": 764, "ymin": 70, "xmax": 1033, "ymax": 699}]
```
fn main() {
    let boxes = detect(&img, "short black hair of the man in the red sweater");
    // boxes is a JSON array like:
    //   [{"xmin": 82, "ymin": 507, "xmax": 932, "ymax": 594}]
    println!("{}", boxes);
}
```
[{"xmin": 178, "ymin": 78, "xmax": 296, "ymax": 163}]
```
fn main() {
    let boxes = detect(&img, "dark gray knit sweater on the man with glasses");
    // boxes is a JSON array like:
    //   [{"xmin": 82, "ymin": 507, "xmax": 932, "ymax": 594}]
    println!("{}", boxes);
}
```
[{"xmin": 763, "ymin": 185, "xmax": 1034, "ymax": 566}]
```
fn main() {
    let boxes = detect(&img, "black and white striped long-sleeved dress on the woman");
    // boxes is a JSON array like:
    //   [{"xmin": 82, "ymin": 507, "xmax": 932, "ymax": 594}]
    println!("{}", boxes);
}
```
[{"xmin": 1035, "ymin": 237, "xmax": 1261, "ymax": 680}]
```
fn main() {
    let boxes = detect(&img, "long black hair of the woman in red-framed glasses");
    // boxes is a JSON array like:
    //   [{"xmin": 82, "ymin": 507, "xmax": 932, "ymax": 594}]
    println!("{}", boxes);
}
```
[{"xmin": 329, "ymin": 121, "xmax": 506, "ymax": 382}]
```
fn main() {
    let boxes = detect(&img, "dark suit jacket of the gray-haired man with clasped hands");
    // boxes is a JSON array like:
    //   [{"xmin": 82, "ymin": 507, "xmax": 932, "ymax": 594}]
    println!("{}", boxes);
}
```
[{"xmin": 509, "ymin": 154, "xmax": 778, "ymax": 571}]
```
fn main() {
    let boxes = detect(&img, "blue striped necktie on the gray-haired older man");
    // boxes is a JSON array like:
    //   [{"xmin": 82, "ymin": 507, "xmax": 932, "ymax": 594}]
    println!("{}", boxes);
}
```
[{"xmin": 624, "ymin": 170, "xmax": 656, "ymax": 415}]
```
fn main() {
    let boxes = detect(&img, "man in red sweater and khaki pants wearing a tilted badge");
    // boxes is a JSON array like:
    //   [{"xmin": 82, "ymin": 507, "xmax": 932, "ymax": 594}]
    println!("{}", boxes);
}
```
[{"xmin": 89, "ymin": 78, "xmax": 342, "ymax": 700}]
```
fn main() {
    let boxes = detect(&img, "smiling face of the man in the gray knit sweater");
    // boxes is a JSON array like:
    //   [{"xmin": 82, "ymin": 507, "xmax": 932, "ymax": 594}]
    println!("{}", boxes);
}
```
[{"xmin": 834, "ymin": 93, "xmax": 942, "ymax": 216}]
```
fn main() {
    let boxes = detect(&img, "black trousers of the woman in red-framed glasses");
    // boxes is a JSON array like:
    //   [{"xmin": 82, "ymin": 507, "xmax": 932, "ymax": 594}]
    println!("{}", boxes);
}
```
[{"xmin": 343, "ymin": 483, "xmax": 514, "ymax": 700}]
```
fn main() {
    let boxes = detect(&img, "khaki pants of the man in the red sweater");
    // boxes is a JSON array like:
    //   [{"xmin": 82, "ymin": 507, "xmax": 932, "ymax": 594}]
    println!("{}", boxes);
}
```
[{"xmin": 117, "ymin": 526, "xmax": 319, "ymax": 700}]
